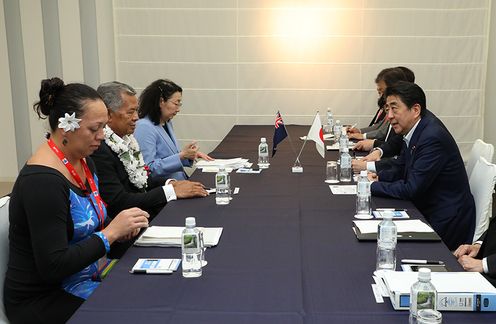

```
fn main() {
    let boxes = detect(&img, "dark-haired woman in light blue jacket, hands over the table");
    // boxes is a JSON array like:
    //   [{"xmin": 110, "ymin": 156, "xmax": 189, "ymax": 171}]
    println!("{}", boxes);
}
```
[{"xmin": 134, "ymin": 79, "xmax": 212, "ymax": 180}]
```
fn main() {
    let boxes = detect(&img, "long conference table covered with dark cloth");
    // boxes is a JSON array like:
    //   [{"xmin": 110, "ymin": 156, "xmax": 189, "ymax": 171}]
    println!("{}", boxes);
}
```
[{"xmin": 69, "ymin": 125, "xmax": 496, "ymax": 324}]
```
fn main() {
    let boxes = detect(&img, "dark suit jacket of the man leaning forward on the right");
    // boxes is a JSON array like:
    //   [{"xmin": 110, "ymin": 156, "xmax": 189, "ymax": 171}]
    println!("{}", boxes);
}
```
[{"xmin": 371, "ymin": 111, "xmax": 475, "ymax": 250}]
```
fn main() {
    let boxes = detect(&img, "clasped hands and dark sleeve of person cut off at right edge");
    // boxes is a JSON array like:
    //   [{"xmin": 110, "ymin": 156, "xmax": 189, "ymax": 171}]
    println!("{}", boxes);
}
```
[{"xmin": 453, "ymin": 217, "xmax": 496, "ymax": 287}]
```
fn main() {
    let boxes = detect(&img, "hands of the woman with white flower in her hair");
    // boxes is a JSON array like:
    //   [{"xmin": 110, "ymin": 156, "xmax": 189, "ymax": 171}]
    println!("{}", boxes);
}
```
[{"xmin": 102, "ymin": 207, "xmax": 150, "ymax": 244}]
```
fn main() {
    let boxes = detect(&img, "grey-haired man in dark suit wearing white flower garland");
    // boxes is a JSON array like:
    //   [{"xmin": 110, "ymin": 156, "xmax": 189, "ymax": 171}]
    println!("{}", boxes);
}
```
[{"xmin": 91, "ymin": 81, "xmax": 208, "ymax": 217}]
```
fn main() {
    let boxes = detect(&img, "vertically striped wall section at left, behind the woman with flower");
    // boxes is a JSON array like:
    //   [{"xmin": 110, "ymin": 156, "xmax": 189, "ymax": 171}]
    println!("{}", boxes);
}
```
[{"xmin": 0, "ymin": 0, "xmax": 115, "ymax": 181}]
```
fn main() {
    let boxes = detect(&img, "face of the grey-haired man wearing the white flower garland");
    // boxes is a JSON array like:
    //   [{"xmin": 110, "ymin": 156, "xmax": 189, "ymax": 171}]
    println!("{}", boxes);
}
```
[{"xmin": 108, "ymin": 93, "xmax": 139, "ymax": 137}]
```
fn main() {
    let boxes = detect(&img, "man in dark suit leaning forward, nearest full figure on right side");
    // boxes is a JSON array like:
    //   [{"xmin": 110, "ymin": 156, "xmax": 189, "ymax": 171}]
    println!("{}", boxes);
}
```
[{"xmin": 370, "ymin": 82, "xmax": 475, "ymax": 250}]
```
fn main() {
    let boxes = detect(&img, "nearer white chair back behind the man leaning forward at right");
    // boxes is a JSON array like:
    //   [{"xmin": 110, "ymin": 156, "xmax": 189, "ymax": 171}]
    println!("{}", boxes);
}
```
[{"xmin": 469, "ymin": 157, "xmax": 496, "ymax": 242}]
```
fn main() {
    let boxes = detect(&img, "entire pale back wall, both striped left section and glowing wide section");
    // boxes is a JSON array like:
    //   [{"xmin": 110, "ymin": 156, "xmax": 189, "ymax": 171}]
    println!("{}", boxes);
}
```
[{"xmin": 0, "ymin": 0, "xmax": 496, "ymax": 180}]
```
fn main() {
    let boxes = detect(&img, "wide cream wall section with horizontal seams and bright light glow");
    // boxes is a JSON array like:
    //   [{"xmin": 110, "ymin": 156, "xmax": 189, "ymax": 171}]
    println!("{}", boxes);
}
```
[{"xmin": 114, "ymin": 0, "xmax": 490, "ymax": 158}]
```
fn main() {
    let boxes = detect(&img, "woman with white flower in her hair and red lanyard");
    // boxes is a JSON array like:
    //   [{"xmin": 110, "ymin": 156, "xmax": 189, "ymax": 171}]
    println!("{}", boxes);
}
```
[{"xmin": 4, "ymin": 78, "xmax": 149, "ymax": 323}]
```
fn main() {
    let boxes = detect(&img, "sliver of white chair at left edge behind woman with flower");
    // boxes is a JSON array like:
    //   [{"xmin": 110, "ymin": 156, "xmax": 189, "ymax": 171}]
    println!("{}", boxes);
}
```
[{"xmin": 0, "ymin": 196, "xmax": 10, "ymax": 323}]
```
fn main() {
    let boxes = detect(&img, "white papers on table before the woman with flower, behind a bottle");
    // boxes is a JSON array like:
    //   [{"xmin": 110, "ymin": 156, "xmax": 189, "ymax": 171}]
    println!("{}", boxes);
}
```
[{"xmin": 134, "ymin": 226, "xmax": 223, "ymax": 247}]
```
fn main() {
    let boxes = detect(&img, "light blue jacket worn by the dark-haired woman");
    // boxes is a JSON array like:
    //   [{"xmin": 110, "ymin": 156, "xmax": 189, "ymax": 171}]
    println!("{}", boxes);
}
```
[{"xmin": 134, "ymin": 117, "xmax": 193, "ymax": 180}]
